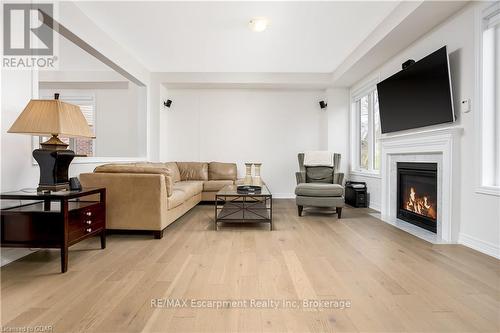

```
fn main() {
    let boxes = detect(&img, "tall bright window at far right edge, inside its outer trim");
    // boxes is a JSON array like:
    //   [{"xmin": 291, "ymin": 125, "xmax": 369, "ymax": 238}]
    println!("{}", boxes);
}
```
[{"xmin": 478, "ymin": 2, "xmax": 500, "ymax": 194}]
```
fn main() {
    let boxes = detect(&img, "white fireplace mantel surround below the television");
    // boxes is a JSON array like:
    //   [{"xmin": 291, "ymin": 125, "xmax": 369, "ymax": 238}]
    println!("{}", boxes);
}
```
[{"xmin": 381, "ymin": 127, "xmax": 463, "ymax": 243}]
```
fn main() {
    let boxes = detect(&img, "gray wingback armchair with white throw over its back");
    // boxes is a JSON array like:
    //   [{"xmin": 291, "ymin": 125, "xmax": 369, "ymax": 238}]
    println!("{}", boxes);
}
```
[{"xmin": 295, "ymin": 153, "xmax": 344, "ymax": 218}]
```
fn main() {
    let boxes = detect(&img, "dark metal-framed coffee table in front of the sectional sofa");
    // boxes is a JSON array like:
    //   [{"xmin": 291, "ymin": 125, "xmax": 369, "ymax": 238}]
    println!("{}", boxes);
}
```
[{"xmin": 214, "ymin": 185, "xmax": 273, "ymax": 230}]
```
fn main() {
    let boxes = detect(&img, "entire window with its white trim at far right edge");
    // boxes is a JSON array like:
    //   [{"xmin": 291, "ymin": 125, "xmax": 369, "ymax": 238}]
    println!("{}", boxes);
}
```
[{"xmin": 474, "ymin": 2, "xmax": 500, "ymax": 196}]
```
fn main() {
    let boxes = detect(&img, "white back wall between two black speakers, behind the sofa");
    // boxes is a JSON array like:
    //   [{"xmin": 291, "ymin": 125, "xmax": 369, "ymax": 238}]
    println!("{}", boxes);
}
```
[{"xmin": 160, "ymin": 89, "xmax": 328, "ymax": 197}]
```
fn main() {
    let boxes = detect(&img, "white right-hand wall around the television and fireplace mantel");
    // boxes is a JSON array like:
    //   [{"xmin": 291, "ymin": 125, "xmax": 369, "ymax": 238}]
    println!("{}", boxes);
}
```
[{"xmin": 351, "ymin": 5, "xmax": 500, "ymax": 254}]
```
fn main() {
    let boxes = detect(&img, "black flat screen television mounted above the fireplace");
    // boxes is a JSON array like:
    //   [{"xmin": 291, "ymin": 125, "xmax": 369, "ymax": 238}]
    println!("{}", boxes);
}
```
[{"xmin": 377, "ymin": 46, "xmax": 455, "ymax": 133}]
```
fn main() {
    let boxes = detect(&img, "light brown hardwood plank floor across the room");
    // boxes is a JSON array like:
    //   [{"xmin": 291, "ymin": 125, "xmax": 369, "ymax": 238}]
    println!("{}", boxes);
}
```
[{"xmin": 1, "ymin": 200, "xmax": 500, "ymax": 332}]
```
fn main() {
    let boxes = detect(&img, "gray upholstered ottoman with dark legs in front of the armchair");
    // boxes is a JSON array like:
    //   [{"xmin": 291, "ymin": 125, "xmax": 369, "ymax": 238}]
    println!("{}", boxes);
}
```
[{"xmin": 295, "ymin": 183, "xmax": 344, "ymax": 218}]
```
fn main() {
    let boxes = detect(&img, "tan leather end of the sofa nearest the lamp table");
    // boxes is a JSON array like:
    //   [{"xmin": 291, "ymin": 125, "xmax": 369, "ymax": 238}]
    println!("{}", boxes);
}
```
[{"xmin": 80, "ymin": 172, "xmax": 167, "ymax": 230}]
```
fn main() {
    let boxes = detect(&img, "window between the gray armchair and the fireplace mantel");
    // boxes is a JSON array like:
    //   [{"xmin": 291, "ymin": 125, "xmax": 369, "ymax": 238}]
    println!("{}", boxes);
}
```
[{"xmin": 352, "ymin": 89, "xmax": 381, "ymax": 173}]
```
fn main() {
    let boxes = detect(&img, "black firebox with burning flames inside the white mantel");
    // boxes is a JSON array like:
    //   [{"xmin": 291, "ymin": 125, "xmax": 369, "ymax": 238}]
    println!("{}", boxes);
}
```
[{"xmin": 397, "ymin": 162, "xmax": 438, "ymax": 233}]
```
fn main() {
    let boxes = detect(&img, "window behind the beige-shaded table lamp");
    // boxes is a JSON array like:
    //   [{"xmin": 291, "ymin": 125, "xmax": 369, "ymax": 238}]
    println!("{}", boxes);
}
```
[{"xmin": 39, "ymin": 95, "xmax": 95, "ymax": 157}]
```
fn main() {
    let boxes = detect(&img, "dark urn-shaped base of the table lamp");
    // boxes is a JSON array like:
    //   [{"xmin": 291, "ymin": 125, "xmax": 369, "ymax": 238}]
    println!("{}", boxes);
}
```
[{"xmin": 33, "ymin": 149, "xmax": 75, "ymax": 191}]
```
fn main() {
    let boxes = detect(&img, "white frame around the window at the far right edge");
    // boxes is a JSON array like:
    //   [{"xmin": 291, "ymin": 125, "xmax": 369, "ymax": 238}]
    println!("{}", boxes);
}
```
[{"xmin": 474, "ymin": 3, "xmax": 500, "ymax": 196}]
